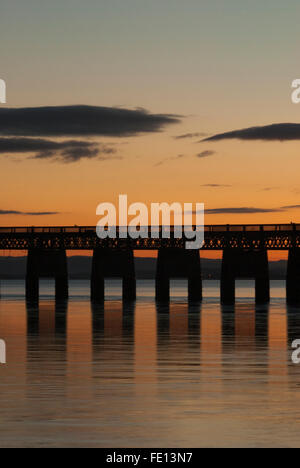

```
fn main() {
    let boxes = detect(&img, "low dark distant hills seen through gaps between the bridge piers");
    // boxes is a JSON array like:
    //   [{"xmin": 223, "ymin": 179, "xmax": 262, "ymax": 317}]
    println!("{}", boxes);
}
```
[{"xmin": 0, "ymin": 256, "xmax": 287, "ymax": 279}]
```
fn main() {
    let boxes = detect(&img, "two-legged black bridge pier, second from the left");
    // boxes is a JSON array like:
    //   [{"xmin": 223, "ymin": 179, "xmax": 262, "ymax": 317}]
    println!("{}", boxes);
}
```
[{"xmin": 91, "ymin": 248, "xmax": 136, "ymax": 302}]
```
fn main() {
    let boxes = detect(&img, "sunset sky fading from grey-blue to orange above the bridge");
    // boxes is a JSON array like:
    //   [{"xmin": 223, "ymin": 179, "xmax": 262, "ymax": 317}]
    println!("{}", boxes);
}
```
[{"xmin": 0, "ymin": 0, "xmax": 300, "ymax": 230}]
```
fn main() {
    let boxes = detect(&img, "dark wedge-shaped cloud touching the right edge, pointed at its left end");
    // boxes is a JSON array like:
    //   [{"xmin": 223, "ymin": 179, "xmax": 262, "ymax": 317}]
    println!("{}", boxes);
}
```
[{"xmin": 202, "ymin": 123, "xmax": 300, "ymax": 141}]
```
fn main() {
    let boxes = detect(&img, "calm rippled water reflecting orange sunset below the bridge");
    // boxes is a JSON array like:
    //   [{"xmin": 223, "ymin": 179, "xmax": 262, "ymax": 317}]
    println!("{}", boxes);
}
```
[{"xmin": 0, "ymin": 281, "xmax": 300, "ymax": 447}]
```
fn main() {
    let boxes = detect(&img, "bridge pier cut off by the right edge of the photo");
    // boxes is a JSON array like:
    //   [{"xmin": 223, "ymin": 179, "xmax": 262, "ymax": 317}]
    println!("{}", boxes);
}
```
[{"xmin": 286, "ymin": 248, "xmax": 300, "ymax": 306}]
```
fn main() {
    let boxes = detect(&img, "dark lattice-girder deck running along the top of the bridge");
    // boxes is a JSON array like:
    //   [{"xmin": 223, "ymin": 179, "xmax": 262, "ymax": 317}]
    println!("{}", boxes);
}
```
[{"xmin": 0, "ymin": 224, "xmax": 300, "ymax": 250}]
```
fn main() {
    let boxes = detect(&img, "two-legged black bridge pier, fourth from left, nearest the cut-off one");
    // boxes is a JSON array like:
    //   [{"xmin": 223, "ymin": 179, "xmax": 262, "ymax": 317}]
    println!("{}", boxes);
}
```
[{"xmin": 221, "ymin": 248, "xmax": 270, "ymax": 305}]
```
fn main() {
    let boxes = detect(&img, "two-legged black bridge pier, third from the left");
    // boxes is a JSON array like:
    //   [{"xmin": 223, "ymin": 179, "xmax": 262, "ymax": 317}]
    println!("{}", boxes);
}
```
[{"xmin": 155, "ymin": 248, "xmax": 202, "ymax": 302}]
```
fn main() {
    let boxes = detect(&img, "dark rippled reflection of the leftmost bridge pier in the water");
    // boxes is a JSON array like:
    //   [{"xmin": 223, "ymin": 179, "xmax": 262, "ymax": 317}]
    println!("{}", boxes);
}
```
[{"xmin": 25, "ymin": 301, "xmax": 68, "ymax": 410}]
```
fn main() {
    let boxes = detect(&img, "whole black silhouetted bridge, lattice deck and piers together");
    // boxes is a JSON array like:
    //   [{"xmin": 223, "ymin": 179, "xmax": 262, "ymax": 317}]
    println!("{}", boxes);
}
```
[{"xmin": 0, "ymin": 223, "xmax": 300, "ymax": 306}]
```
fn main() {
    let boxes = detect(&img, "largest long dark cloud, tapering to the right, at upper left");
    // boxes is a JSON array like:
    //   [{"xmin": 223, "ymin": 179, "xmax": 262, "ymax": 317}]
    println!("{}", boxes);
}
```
[{"xmin": 0, "ymin": 106, "xmax": 180, "ymax": 137}]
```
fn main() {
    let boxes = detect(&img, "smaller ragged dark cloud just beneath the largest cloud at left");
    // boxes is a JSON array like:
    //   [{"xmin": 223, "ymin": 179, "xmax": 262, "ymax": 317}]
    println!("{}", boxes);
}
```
[{"xmin": 0, "ymin": 138, "xmax": 120, "ymax": 163}]
